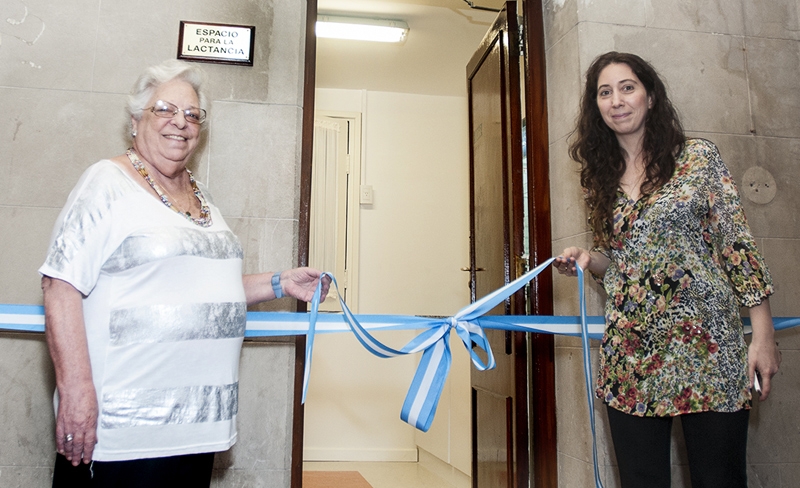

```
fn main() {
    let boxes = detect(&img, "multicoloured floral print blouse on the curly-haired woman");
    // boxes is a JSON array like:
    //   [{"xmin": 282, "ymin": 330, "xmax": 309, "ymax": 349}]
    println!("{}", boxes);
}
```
[{"xmin": 596, "ymin": 139, "xmax": 773, "ymax": 416}]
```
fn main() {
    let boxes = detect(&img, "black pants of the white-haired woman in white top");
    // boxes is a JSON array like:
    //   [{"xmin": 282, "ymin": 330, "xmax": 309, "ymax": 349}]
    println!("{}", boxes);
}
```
[{"xmin": 53, "ymin": 452, "xmax": 214, "ymax": 488}]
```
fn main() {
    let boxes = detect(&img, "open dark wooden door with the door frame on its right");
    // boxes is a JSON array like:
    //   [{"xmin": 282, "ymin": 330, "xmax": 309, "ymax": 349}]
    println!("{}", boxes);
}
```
[{"xmin": 467, "ymin": 0, "xmax": 558, "ymax": 488}]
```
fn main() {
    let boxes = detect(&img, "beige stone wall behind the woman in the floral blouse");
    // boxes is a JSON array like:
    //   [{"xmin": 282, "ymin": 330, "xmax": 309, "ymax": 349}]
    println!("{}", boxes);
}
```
[{"xmin": 544, "ymin": 0, "xmax": 800, "ymax": 488}]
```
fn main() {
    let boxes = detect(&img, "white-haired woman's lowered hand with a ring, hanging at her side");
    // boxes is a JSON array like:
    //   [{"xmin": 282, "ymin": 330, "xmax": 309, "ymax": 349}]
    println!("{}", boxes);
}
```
[{"xmin": 56, "ymin": 381, "xmax": 98, "ymax": 466}]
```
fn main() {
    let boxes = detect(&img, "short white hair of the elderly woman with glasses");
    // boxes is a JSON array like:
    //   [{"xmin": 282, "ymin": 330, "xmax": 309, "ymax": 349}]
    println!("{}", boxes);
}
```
[{"xmin": 127, "ymin": 59, "xmax": 210, "ymax": 127}]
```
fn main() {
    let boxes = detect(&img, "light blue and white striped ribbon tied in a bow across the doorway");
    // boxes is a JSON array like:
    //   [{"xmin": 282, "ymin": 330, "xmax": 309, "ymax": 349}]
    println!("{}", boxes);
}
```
[{"xmin": 0, "ymin": 258, "xmax": 800, "ymax": 488}]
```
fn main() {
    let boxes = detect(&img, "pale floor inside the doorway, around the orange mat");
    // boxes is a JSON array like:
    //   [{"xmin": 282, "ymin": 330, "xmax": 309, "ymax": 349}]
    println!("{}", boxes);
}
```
[{"xmin": 303, "ymin": 462, "xmax": 454, "ymax": 488}]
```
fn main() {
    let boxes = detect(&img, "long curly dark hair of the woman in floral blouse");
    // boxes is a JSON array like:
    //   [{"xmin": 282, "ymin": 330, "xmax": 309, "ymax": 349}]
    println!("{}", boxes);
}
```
[{"xmin": 569, "ymin": 51, "xmax": 686, "ymax": 246}]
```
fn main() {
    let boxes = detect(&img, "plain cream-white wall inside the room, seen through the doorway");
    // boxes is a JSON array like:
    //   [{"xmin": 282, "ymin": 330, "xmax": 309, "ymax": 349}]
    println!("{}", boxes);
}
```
[{"xmin": 304, "ymin": 89, "xmax": 470, "ymax": 473}]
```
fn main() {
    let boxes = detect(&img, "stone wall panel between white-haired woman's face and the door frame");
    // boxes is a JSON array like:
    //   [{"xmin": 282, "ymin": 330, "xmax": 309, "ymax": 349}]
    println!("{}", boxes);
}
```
[{"xmin": 207, "ymin": 102, "xmax": 302, "ymax": 219}]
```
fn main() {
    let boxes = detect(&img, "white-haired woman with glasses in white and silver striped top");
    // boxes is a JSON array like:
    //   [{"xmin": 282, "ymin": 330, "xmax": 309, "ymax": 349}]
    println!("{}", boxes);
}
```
[{"xmin": 39, "ymin": 61, "xmax": 328, "ymax": 487}]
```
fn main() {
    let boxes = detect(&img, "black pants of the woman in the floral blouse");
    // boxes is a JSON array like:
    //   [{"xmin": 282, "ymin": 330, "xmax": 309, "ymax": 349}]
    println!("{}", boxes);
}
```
[{"xmin": 608, "ymin": 407, "xmax": 750, "ymax": 488}]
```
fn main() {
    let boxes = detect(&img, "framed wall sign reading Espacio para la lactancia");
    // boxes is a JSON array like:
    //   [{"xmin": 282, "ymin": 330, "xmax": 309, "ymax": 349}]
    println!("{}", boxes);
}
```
[{"xmin": 178, "ymin": 20, "xmax": 256, "ymax": 66}]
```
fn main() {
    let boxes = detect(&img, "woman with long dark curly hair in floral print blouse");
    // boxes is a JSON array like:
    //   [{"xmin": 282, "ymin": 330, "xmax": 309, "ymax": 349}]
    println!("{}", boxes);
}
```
[{"xmin": 557, "ymin": 52, "xmax": 780, "ymax": 488}]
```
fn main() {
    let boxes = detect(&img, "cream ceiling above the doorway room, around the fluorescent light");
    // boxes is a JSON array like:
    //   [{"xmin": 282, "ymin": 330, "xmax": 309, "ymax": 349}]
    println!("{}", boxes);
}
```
[{"xmin": 316, "ymin": 0, "xmax": 504, "ymax": 96}]
